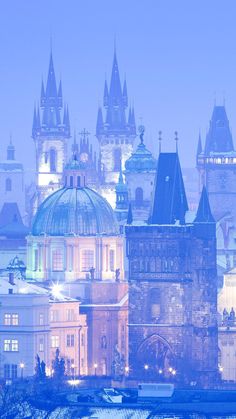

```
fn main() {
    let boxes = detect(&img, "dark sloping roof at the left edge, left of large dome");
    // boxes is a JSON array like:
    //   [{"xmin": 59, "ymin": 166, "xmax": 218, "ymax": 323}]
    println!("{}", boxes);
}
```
[{"xmin": 0, "ymin": 202, "xmax": 29, "ymax": 238}]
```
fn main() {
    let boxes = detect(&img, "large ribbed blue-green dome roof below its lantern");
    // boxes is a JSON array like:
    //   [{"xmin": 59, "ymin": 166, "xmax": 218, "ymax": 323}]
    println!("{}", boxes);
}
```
[{"xmin": 31, "ymin": 187, "xmax": 119, "ymax": 236}]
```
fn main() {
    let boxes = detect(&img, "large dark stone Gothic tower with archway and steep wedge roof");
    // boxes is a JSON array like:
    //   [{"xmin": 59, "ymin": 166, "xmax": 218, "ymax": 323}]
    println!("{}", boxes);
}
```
[{"xmin": 126, "ymin": 153, "xmax": 218, "ymax": 387}]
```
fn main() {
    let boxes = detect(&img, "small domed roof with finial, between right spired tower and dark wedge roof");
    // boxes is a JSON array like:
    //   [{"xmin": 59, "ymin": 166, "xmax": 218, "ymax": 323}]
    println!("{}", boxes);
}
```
[{"xmin": 125, "ymin": 133, "xmax": 157, "ymax": 172}]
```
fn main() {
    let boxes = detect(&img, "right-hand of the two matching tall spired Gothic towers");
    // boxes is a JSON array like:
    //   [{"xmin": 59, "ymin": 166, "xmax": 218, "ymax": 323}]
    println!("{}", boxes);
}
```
[{"xmin": 96, "ymin": 51, "xmax": 136, "ymax": 208}]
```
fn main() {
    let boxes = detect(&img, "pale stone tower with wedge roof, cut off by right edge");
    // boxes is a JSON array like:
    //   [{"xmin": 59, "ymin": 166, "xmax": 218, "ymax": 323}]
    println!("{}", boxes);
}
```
[{"xmin": 196, "ymin": 106, "xmax": 236, "ymax": 270}]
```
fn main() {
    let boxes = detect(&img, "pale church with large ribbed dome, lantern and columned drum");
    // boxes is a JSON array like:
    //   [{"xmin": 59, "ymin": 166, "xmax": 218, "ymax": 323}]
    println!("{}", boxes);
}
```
[{"xmin": 26, "ymin": 154, "xmax": 128, "ymax": 375}]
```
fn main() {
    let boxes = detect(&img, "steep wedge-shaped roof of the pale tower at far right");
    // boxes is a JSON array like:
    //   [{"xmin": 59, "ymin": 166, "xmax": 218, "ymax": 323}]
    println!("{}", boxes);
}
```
[{"xmin": 205, "ymin": 106, "xmax": 234, "ymax": 155}]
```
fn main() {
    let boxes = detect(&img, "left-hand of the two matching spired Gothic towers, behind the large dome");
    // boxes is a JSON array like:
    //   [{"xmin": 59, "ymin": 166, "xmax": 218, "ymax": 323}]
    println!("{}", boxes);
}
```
[{"xmin": 32, "ymin": 53, "xmax": 70, "ymax": 212}]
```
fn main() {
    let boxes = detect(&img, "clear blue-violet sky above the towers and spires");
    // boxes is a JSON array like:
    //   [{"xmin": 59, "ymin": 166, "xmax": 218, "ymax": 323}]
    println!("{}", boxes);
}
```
[{"xmin": 0, "ymin": 0, "xmax": 236, "ymax": 180}]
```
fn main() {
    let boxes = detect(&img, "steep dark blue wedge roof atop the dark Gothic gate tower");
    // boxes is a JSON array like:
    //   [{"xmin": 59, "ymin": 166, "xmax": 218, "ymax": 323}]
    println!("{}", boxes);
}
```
[{"xmin": 150, "ymin": 153, "xmax": 188, "ymax": 224}]
